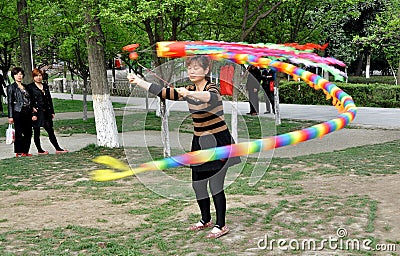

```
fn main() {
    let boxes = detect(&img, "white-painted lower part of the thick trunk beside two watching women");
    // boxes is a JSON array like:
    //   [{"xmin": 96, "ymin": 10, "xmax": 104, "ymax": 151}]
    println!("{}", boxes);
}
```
[{"xmin": 92, "ymin": 94, "xmax": 119, "ymax": 148}]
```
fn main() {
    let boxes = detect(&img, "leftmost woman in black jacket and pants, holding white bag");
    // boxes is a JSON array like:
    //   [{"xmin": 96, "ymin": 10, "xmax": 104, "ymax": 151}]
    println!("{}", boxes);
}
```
[{"xmin": 7, "ymin": 67, "xmax": 36, "ymax": 157}]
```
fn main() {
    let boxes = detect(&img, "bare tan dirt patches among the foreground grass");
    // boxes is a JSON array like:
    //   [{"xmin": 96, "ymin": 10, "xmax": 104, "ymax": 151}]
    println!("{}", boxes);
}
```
[{"xmin": 0, "ymin": 130, "xmax": 400, "ymax": 254}]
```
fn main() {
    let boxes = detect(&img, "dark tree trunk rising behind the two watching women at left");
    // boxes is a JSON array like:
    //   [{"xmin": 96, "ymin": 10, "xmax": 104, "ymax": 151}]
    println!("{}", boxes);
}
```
[{"xmin": 17, "ymin": 0, "xmax": 33, "ymax": 84}]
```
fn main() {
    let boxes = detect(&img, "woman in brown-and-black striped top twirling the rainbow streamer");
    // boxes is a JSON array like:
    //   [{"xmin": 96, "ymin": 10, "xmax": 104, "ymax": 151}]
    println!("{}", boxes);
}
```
[{"xmin": 128, "ymin": 55, "xmax": 240, "ymax": 238}]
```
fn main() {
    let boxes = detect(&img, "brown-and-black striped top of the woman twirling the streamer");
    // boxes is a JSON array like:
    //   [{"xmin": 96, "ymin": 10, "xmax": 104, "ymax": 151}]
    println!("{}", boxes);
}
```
[{"xmin": 149, "ymin": 82, "xmax": 228, "ymax": 136}]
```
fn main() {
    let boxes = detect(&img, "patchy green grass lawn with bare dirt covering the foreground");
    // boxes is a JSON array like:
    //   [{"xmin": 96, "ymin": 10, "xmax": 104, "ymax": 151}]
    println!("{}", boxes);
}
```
[{"xmin": 0, "ymin": 138, "xmax": 400, "ymax": 255}]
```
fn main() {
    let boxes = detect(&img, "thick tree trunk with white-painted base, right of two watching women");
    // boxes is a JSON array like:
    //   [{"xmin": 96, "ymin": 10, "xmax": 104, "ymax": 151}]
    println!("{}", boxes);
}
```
[{"xmin": 86, "ymin": 7, "xmax": 119, "ymax": 148}]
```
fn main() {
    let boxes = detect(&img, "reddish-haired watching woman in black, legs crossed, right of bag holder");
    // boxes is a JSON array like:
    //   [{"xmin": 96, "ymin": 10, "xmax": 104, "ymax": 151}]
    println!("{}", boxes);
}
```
[{"xmin": 28, "ymin": 68, "xmax": 68, "ymax": 155}]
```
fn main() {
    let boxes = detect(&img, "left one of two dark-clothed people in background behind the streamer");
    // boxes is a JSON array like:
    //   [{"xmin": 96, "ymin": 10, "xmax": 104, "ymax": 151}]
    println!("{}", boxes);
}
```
[{"xmin": 246, "ymin": 65, "xmax": 261, "ymax": 116}]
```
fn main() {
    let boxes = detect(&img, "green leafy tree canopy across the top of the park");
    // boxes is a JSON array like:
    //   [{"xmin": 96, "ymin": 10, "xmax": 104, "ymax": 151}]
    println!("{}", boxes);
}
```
[{"xmin": 0, "ymin": 0, "xmax": 400, "ymax": 78}]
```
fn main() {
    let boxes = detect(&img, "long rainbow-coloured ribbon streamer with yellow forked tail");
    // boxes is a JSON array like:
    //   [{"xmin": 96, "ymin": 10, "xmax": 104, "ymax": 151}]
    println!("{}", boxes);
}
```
[{"xmin": 92, "ymin": 41, "xmax": 357, "ymax": 181}]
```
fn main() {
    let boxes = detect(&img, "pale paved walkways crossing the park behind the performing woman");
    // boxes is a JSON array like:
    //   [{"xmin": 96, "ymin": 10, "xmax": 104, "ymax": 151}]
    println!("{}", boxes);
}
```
[{"xmin": 0, "ymin": 93, "xmax": 400, "ymax": 159}]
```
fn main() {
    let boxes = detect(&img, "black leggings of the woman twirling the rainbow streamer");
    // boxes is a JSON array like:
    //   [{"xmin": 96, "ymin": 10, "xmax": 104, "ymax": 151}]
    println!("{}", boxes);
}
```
[{"xmin": 192, "ymin": 167, "xmax": 228, "ymax": 228}]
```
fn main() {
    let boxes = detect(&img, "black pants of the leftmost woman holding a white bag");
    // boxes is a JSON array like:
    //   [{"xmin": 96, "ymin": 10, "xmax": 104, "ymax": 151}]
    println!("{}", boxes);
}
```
[{"xmin": 13, "ymin": 109, "xmax": 32, "ymax": 153}]
